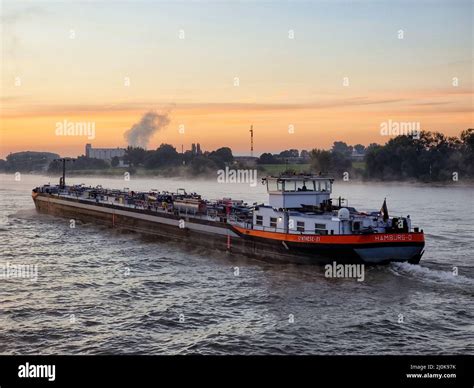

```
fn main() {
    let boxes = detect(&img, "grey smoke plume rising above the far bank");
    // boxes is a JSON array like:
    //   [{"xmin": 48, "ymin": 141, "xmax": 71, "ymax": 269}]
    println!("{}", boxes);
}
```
[{"xmin": 124, "ymin": 111, "xmax": 170, "ymax": 149}]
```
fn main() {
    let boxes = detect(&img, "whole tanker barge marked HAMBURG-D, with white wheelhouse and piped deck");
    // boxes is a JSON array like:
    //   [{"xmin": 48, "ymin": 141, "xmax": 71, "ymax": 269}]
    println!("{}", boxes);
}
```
[{"xmin": 32, "ymin": 175, "xmax": 424, "ymax": 264}]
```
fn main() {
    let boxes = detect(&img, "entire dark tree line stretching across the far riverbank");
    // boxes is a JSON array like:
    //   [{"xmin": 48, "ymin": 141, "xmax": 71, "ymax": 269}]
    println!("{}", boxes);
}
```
[{"xmin": 0, "ymin": 128, "xmax": 474, "ymax": 181}]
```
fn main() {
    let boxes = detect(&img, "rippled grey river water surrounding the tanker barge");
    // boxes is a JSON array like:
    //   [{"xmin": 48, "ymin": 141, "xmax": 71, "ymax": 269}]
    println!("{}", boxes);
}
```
[{"xmin": 0, "ymin": 175, "xmax": 474, "ymax": 354}]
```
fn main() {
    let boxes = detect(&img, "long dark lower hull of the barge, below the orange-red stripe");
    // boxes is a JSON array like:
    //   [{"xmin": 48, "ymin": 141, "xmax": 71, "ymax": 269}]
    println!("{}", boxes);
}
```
[{"xmin": 33, "ymin": 194, "xmax": 424, "ymax": 264}]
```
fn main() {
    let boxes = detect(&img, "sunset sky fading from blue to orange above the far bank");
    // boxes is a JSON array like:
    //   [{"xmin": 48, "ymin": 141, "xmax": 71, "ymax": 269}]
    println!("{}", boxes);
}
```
[{"xmin": 0, "ymin": 0, "xmax": 474, "ymax": 158}]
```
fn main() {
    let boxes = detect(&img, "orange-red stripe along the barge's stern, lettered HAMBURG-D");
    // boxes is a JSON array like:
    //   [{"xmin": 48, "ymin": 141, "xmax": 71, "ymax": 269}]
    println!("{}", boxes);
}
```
[{"xmin": 233, "ymin": 225, "xmax": 425, "ymax": 244}]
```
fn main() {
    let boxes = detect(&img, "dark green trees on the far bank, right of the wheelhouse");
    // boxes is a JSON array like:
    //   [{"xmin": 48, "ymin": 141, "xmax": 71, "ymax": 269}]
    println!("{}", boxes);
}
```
[{"xmin": 310, "ymin": 128, "xmax": 474, "ymax": 181}]
